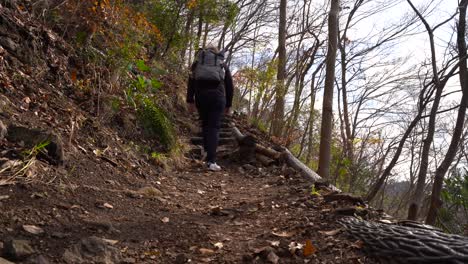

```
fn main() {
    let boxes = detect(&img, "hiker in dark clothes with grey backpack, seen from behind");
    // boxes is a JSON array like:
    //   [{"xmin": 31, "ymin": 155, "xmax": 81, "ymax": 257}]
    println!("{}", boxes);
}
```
[{"xmin": 187, "ymin": 45, "xmax": 234, "ymax": 171}]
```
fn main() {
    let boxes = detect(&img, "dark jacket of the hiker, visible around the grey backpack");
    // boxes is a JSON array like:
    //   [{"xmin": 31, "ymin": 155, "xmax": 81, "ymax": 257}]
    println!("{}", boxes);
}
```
[{"xmin": 186, "ymin": 62, "xmax": 234, "ymax": 107}]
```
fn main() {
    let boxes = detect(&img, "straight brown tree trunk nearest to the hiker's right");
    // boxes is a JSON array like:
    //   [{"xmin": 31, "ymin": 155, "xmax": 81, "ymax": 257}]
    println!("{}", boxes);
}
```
[{"xmin": 271, "ymin": 0, "xmax": 287, "ymax": 137}]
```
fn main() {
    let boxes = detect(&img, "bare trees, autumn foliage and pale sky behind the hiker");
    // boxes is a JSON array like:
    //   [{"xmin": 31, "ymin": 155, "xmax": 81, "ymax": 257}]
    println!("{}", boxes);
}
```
[{"xmin": 24, "ymin": 0, "xmax": 468, "ymax": 233}]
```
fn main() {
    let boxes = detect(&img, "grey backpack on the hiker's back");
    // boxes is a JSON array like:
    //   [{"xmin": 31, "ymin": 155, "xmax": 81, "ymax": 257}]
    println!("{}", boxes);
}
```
[{"xmin": 193, "ymin": 49, "xmax": 225, "ymax": 82}]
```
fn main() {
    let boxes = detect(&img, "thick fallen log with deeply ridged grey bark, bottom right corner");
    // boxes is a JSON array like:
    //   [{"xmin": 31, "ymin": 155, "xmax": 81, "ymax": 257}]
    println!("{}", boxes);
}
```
[{"xmin": 338, "ymin": 217, "xmax": 468, "ymax": 264}]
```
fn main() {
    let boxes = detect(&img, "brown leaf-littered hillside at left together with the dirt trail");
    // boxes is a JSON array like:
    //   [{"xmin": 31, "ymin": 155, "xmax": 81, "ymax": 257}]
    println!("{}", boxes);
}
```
[{"xmin": 0, "ymin": 0, "xmax": 376, "ymax": 264}]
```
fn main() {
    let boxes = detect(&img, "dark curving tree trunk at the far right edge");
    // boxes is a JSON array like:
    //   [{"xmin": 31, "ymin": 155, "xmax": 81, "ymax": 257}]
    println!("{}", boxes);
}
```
[{"xmin": 426, "ymin": 0, "xmax": 468, "ymax": 225}]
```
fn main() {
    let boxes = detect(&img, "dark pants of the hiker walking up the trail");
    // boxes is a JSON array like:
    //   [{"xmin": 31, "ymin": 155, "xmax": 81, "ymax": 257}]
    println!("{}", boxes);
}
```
[{"xmin": 196, "ymin": 93, "xmax": 226, "ymax": 162}]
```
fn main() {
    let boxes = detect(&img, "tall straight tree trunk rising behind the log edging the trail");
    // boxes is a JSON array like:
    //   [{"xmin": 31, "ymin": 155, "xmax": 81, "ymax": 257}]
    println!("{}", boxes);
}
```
[{"xmin": 318, "ymin": 0, "xmax": 340, "ymax": 179}]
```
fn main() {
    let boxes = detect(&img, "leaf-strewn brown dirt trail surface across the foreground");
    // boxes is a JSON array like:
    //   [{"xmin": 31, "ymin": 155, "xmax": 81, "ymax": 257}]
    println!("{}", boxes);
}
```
[{"xmin": 0, "ymin": 116, "xmax": 376, "ymax": 263}]
